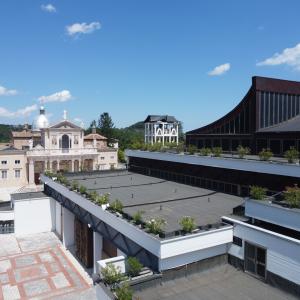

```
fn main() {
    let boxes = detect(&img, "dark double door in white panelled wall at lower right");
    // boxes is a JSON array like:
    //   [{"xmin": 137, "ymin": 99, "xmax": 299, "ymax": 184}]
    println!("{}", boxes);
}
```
[{"xmin": 245, "ymin": 242, "xmax": 266, "ymax": 279}]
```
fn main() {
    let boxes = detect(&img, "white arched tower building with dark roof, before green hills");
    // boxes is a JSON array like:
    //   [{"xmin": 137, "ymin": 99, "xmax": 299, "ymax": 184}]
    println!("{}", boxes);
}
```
[{"xmin": 144, "ymin": 115, "xmax": 178, "ymax": 145}]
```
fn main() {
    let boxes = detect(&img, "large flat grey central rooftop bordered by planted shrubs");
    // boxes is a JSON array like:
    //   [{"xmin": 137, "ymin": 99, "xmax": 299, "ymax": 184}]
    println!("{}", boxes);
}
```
[{"xmin": 68, "ymin": 171, "xmax": 243, "ymax": 232}]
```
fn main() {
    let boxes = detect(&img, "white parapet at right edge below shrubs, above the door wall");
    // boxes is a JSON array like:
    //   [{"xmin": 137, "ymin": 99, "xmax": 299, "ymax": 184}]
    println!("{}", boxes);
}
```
[{"xmin": 245, "ymin": 199, "xmax": 300, "ymax": 231}]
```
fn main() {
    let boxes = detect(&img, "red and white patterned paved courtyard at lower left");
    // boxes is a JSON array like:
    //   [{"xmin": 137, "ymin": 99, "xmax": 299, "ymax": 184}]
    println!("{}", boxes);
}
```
[{"xmin": 0, "ymin": 233, "xmax": 93, "ymax": 300}]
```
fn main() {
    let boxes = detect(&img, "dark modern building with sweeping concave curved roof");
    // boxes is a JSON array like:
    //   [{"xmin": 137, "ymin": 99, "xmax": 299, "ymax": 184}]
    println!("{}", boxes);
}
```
[{"xmin": 186, "ymin": 76, "xmax": 300, "ymax": 155}]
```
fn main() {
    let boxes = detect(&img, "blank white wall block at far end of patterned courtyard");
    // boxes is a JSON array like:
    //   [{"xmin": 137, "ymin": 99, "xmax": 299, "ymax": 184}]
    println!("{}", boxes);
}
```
[{"xmin": 14, "ymin": 197, "xmax": 56, "ymax": 236}]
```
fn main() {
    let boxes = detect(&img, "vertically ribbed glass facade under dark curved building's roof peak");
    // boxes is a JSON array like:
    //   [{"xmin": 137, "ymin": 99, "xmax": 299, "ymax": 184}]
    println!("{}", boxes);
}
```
[{"xmin": 259, "ymin": 91, "xmax": 300, "ymax": 128}]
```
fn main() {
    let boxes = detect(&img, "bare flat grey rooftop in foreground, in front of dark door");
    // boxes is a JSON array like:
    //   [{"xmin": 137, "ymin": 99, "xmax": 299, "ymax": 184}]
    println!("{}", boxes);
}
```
[{"xmin": 134, "ymin": 265, "xmax": 298, "ymax": 300}]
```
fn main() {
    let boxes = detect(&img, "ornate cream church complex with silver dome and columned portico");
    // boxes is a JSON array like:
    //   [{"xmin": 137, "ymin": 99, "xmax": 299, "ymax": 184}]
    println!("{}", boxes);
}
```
[{"xmin": 0, "ymin": 107, "xmax": 118, "ymax": 201}]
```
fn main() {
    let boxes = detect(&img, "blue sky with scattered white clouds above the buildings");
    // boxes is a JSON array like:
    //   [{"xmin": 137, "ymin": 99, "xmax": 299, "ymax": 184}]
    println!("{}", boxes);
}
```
[{"xmin": 0, "ymin": 0, "xmax": 300, "ymax": 130}]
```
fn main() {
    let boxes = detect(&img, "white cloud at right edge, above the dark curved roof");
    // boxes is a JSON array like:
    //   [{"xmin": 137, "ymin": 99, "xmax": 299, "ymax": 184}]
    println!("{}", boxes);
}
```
[{"xmin": 256, "ymin": 43, "xmax": 300, "ymax": 71}]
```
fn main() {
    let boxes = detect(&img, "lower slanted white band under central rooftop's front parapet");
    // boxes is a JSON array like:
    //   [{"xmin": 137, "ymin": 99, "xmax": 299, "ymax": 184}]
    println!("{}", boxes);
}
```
[{"xmin": 159, "ymin": 244, "xmax": 227, "ymax": 271}]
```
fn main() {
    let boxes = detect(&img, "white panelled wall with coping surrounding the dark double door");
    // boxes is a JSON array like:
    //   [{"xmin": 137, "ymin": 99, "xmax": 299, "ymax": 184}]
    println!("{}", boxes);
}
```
[{"xmin": 223, "ymin": 217, "xmax": 300, "ymax": 285}]
